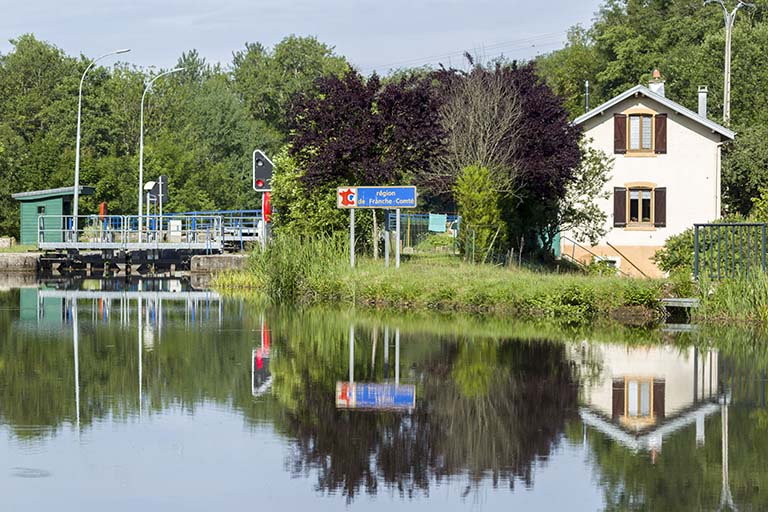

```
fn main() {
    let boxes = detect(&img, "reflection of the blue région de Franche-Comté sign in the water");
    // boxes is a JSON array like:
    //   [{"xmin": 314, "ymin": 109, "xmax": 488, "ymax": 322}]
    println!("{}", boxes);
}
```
[{"xmin": 336, "ymin": 382, "xmax": 416, "ymax": 409}]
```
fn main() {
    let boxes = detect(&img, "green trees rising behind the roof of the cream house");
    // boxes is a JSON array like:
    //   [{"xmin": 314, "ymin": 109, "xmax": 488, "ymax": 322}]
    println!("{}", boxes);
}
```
[{"xmin": 538, "ymin": 0, "xmax": 768, "ymax": 215}]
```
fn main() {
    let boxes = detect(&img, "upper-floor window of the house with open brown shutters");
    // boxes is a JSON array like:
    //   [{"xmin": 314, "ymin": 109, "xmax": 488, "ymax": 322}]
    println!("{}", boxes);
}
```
[{"xmin": 613, "ymin": 109, "xmax": 667, "ymax": 156}]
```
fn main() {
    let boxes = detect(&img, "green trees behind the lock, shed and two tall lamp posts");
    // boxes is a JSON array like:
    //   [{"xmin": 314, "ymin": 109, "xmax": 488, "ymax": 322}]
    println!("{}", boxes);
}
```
[{"xmin": 0, "ymin": 35, "xmax": 322, "ymax": 236}]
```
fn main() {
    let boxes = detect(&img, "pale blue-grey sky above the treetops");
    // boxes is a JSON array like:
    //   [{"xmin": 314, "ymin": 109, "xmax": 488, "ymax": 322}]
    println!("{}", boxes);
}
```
[{"xmin": 0, "ymin": 0, "xmax": 601, "ymax": 74}]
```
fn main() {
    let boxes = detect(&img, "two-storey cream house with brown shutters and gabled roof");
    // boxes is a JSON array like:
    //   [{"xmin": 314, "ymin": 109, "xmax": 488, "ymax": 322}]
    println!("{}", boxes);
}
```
[{"xmin": 561, "ymin": 71, "xmax": 735, "ymax": 277}]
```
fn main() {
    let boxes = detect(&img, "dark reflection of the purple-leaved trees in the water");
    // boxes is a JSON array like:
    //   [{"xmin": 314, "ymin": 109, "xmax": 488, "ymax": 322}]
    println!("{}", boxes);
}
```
[{"xmin": 276, "ymin": 341, "xmax": 577, "ymax": 499}]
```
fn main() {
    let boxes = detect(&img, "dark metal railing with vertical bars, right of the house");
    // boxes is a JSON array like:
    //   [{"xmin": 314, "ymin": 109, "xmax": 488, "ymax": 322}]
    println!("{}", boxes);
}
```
[{"xmin": 693, "ymin": 223, "xmax": 768, "ymax": 279}]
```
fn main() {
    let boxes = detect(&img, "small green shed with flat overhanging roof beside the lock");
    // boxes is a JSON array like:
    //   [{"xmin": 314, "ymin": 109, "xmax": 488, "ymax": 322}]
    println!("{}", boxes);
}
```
[{"xmin": 11, "ymin": 186, "xmax": 95, "ymax": 245}]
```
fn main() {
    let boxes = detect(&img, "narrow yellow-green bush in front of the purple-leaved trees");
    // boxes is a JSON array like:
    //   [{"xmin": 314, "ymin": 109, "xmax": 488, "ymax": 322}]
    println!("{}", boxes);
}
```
[{"xmin": 454, "ymin": 165, "xmax": 505, "ymax": 262}]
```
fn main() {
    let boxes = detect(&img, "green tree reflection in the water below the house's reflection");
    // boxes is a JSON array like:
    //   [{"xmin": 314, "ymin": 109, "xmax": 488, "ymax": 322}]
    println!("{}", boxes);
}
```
[{"xmin": 579, "ymin": 406, "xmax": 768, "ymax": 511}]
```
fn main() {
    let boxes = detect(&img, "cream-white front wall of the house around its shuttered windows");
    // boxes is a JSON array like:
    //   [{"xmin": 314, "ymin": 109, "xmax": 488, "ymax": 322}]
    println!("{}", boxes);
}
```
[{"xmin": 564, "ymin": 97, "xmax": 720, "ymax": 246}]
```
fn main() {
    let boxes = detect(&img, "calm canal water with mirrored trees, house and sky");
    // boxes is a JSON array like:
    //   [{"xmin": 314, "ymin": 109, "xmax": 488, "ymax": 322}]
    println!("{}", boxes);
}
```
[{"xmin": 0, "ymin": 280, "xmax": 768, "ymax": 511}]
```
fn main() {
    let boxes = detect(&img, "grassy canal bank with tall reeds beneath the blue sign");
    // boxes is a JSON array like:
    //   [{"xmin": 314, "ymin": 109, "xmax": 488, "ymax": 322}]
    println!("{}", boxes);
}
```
[{"xmin": 214, "ymin": 234, "xmax": 663, "ymax": 322}]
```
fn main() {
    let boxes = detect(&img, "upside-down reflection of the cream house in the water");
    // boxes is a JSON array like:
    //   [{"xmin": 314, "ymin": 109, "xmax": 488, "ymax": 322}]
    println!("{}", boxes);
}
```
[{"xmin": 572, "ymin": 345, "xmax": 719, "ymax": 451}]
